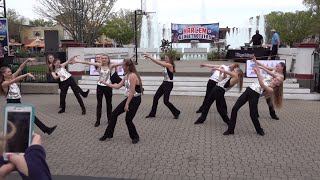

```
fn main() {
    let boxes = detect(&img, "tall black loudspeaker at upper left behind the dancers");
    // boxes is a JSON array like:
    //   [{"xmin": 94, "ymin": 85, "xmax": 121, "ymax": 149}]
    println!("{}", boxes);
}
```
[{"xmin": 44, "ymin": 30, "xmax": 60, "ymax": 52}]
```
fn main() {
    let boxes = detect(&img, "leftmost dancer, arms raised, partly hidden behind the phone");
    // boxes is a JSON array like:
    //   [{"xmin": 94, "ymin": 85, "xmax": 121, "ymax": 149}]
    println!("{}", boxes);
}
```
[{"xmin": 0, "ymin": 58, "xmax": 57, "ymax": 135}]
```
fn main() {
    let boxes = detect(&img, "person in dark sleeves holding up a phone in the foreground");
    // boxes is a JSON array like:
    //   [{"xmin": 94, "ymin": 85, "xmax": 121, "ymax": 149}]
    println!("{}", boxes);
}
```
[{"xmin": 0, "ymin": 128, "xmax": 52, "ymax": 180}]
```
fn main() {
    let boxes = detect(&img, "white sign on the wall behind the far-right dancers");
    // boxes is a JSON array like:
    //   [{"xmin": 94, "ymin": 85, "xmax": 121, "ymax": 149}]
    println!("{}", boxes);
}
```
[{"xmin": 246, "ymin": 59, "xmax": 286, "ymax": 78}]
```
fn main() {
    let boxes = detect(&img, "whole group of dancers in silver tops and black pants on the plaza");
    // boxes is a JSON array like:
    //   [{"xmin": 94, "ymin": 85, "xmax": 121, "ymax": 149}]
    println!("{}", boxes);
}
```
[{"xmin": 0, "ymin": 53, "xmax": 286, "ymax": 144}]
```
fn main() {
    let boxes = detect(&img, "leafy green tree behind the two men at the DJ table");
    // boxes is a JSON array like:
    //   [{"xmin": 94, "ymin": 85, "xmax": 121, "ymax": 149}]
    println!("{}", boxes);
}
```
[{"xmin": 266, "ymin": 11, "xmax": 312, "ymax": 46}]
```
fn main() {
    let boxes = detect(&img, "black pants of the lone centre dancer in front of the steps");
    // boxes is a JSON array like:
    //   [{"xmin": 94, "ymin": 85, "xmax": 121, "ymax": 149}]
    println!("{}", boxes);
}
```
[{"xmin": 149, "ymin": 81, "xmax": 180, "ymax": 116}]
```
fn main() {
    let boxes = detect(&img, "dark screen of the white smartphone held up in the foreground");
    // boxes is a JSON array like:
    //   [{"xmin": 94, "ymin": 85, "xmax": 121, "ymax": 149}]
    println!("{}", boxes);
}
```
[{"xmin": 6, "ymin": 112, "xmax": 31, "ymax": 153}]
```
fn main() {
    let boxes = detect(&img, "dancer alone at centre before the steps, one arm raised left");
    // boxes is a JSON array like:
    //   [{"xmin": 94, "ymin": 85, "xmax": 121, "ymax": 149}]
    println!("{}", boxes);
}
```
[{"xmin": 144, "ymin": 53, "xmax": 180, "ymax": 119}]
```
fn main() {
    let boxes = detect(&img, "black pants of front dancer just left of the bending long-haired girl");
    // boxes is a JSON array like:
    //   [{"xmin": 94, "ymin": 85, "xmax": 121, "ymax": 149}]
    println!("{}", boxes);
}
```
[{"xmin": 199, "ymin": 86, "xmax": 229, "ymax": 123}]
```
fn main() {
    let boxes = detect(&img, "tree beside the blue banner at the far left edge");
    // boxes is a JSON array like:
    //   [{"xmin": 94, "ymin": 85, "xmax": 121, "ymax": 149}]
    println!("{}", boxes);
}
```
[{"xmin": 1, "ymin": 8, "xmax": 27, "ymax": 42}]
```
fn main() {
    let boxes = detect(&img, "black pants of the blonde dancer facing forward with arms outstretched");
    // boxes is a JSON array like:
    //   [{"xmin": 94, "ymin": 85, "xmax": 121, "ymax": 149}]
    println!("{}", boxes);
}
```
[{"xmin": 97, "ymin": 85, "xmax": 112, "ymax": 121}]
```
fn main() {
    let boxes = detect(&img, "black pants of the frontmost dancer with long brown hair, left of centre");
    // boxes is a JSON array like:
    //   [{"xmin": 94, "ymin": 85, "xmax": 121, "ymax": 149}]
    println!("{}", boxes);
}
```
[{"xmin": 104, "ymin": 96, "xmax": 141, "ymax": 139}]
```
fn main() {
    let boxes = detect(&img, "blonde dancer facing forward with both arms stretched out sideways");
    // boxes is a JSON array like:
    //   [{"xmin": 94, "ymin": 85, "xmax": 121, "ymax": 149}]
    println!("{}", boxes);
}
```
[{"xmin": 74, "ymin": 55, "xmax": 122, "ymax": 127}]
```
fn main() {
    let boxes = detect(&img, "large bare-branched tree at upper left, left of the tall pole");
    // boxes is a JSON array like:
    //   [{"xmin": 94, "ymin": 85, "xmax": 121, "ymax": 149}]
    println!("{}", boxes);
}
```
[{"xmin": 34, "ymin": 0, "xmax": 117, "ymax": 46}]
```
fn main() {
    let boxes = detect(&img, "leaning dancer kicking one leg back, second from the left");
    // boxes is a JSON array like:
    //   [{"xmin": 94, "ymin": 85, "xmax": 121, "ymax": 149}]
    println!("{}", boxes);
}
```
[{"xmin": 51, "ymin": 56, "xmax": 89, "ymax": 115}]
